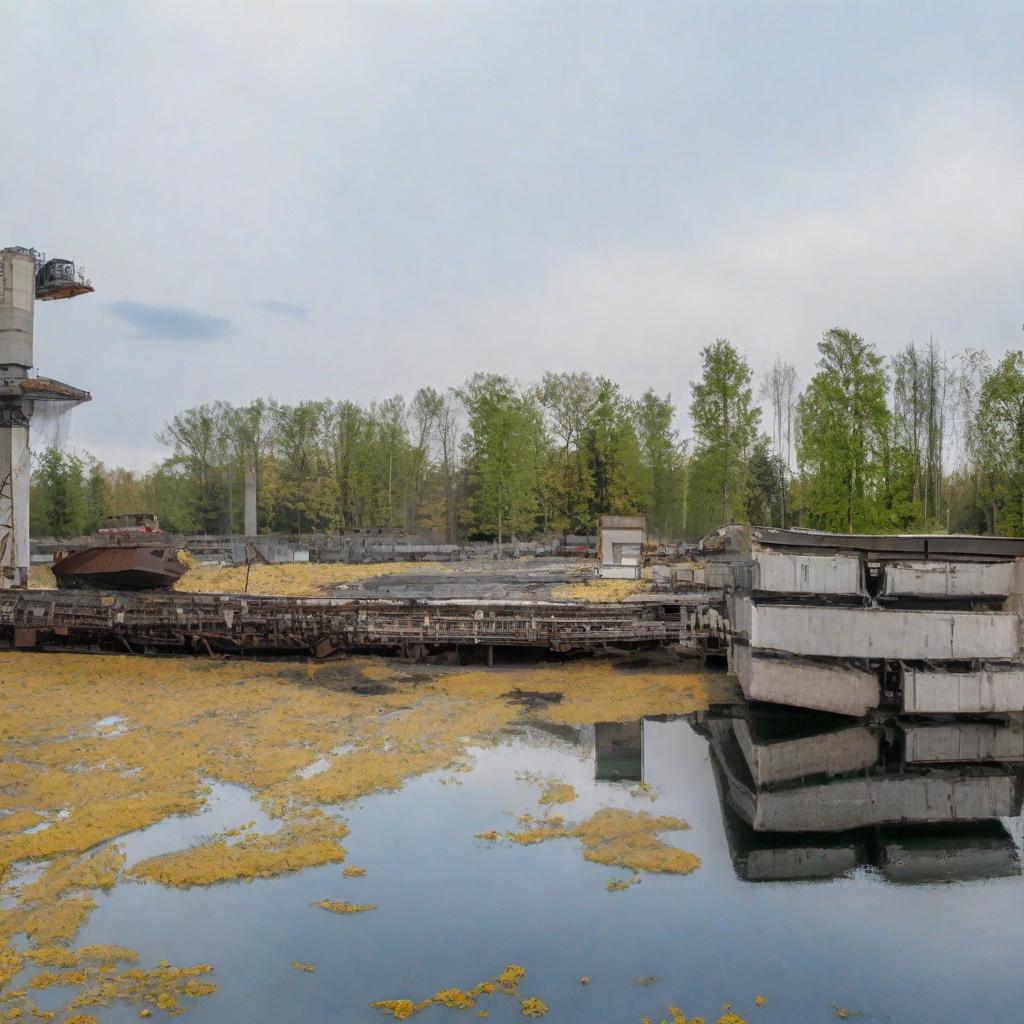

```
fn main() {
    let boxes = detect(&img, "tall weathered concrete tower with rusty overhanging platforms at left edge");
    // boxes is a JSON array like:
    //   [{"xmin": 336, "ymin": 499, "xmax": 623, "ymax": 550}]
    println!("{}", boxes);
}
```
[{"xmin": 0, "ymin": 246, "xmax": 92, "ymax": 590}]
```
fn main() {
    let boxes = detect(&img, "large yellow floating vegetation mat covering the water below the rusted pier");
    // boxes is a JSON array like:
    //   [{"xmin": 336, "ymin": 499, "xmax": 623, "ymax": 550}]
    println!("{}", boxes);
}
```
[{"xmin": 0, "ymin": 655, "xmax": 709, "ymax": 1016}]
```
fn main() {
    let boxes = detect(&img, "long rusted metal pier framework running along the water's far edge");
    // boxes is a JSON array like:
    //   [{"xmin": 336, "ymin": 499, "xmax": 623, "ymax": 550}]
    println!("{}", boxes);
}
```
[{"xmin": 0, "ymin": 590, "xmax": 724, "ymax": 659}]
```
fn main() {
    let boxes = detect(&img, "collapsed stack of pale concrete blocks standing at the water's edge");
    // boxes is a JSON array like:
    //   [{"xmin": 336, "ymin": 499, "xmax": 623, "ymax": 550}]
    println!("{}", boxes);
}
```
[{"xmin": 706, "ymin": 526, "xmax": 1024, "ymax": 716}]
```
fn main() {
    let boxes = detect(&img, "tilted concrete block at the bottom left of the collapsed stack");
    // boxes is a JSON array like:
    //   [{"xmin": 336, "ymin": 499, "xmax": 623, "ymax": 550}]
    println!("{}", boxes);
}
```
[{"xmin": 730, "ymin": 643, "xmax": 880, "ymax": 717}]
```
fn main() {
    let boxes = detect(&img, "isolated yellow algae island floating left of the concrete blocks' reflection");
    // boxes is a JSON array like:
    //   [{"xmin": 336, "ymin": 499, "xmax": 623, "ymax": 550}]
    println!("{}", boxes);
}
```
[{"xmin": 505, "ymin": 807, "xmax": 700, "ymax": 874}]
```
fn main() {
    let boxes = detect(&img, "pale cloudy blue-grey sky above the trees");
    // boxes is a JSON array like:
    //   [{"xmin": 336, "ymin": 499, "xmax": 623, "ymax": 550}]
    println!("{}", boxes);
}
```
[{"xmin": 0, "ymin": 0, "xmax": 1024, "ymax": 469}]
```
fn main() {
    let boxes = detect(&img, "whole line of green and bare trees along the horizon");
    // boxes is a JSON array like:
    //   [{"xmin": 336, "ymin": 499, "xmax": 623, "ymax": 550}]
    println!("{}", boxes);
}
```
[{"xmin": 32, "ymin": 328, "xmax": 1024, "ymax": 542}]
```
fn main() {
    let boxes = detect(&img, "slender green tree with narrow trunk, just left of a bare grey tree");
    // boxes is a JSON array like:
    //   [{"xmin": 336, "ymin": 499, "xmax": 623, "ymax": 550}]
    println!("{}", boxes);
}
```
[{"xmin": 690, "ymin": 338, "xmax": 761, "ymax": 523}]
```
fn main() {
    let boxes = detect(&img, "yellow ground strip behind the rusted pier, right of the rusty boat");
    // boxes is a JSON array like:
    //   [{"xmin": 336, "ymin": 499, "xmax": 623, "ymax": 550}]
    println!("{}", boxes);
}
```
[{"xmin": 174, "ymin": 562, "xmax": 451, "ymax": 597}]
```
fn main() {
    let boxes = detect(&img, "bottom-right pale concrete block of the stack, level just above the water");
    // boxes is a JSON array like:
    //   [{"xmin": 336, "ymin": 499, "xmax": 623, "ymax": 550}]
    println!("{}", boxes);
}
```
[{"xmin": 902, "ymin": 655, "xmax": 1024, "ymax": 715}]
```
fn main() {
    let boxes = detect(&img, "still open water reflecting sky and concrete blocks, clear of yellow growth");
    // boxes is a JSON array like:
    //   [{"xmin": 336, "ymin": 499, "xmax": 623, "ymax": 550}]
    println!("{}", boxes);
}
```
[{"xmin": 41, "ymin": 707, "xmax": 1024, "ymax": 1024}]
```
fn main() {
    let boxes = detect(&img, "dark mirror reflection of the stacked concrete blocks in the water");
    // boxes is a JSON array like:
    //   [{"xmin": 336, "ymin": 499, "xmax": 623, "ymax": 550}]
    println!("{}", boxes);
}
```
[{"xmin": 696, "ymin": 708, "xmax": 1024, "ymax": 883}]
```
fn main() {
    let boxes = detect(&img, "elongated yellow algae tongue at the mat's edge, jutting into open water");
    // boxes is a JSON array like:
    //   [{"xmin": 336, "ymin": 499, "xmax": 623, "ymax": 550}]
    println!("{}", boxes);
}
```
[{"xmin": 122, "ymin": 810, "xmax": 348, "ymax": 888}]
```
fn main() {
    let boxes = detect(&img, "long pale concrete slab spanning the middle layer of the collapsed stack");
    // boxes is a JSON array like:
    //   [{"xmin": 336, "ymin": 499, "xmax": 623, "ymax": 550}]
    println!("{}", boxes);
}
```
[{"xmin": 733, "ymin": 598, "xmax": 1020, "ymax": 660}]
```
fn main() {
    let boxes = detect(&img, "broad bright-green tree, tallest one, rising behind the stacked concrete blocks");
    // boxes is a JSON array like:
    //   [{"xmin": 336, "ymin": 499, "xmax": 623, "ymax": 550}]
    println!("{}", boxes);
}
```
[{"xmin": 798, "ymin": 328, "xmax": 889, "ymax": 532}]
